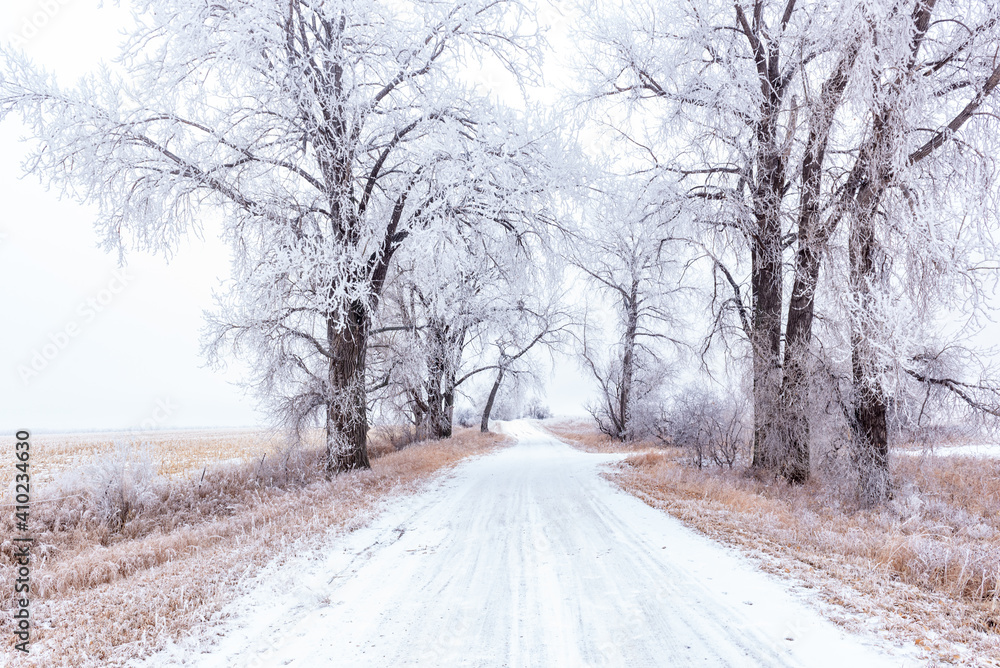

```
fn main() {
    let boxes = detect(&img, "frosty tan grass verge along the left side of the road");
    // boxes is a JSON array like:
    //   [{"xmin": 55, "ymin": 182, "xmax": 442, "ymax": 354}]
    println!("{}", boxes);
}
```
[{"xmin": 0, "ymin": 430, "xmax": 502, "ymax": 666}]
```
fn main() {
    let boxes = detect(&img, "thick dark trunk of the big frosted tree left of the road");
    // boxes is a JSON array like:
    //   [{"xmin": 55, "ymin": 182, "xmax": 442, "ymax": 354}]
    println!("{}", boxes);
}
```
[{"xmin": 326, "ymin": 301, "xmax": 371, "ymax": 475}]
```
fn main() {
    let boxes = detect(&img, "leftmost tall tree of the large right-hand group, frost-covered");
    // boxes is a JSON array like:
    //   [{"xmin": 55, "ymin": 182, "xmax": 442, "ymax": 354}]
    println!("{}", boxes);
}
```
[{"xmin": 584, "ymin": 0, "xmax": 853, "ymax": 470}]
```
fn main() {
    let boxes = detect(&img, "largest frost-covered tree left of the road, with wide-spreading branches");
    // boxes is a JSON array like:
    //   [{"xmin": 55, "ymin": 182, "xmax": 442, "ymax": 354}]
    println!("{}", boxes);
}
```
[{"xmin": 0, "ymin": 0, "xmax": 538, "ymax": 472}]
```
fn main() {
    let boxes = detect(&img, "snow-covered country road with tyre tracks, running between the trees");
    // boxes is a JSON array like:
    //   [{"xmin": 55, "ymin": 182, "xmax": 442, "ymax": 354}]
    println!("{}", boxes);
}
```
[{"xmin": 149, "ymin": 422, "xmax": 917, "ymax": 668}]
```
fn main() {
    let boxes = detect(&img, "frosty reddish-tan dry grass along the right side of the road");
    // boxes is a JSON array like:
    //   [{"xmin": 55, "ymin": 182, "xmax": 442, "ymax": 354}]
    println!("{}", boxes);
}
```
[{"xmin": 546, "ymin": 423, "xmax": 1000, "ymax": 666}]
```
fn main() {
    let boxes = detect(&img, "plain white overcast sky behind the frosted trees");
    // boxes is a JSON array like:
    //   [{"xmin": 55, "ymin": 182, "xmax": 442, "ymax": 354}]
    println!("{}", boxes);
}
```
[{"xmin": 0, "ymin": 0, "xmax": 592, "ymax": 432}]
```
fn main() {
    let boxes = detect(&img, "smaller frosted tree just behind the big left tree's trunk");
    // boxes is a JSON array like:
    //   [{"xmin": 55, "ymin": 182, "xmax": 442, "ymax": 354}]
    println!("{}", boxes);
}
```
[{"xmin": 373, "ymin": 198, "xmax": 537, "ymax": 438}]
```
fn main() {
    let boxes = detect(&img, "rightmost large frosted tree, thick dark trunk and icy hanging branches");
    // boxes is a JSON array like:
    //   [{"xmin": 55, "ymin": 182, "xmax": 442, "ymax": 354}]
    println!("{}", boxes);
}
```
[{"xmin": 827, "ymin": 0, "xmax": 1000, "ymax": 504}]
